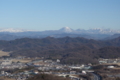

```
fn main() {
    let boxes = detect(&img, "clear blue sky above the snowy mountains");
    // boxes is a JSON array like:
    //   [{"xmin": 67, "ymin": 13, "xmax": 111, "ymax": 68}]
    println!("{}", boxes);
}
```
[{"xmin": 0, "ymin": 0, "xmax": 120, "ymax": 31}]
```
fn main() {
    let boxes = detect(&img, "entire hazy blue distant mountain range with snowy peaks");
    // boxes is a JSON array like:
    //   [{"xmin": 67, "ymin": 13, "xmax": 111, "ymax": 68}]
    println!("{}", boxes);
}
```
[{"xmin": 0, "ymin": 27, "xmax": 120, "ymax": 40}]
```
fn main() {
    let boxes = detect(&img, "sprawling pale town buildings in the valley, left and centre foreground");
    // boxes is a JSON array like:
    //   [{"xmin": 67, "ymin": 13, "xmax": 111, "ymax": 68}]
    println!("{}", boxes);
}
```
[{"xmin": 0, "ymin": 57, "xmax": 91, "ymax": 80}]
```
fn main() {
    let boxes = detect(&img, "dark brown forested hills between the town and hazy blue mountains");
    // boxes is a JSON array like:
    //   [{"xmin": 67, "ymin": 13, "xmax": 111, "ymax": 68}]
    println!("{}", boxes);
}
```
[{"xmin": 0, "ymin": 37, "xmax": 120, "ymax": 63}]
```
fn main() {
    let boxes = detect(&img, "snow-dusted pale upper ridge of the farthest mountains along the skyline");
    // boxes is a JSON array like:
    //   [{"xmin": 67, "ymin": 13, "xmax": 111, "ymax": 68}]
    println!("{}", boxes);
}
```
[{"xmin": 0, "ymin": 27, "xmax": 120, "ymax": 35}]
